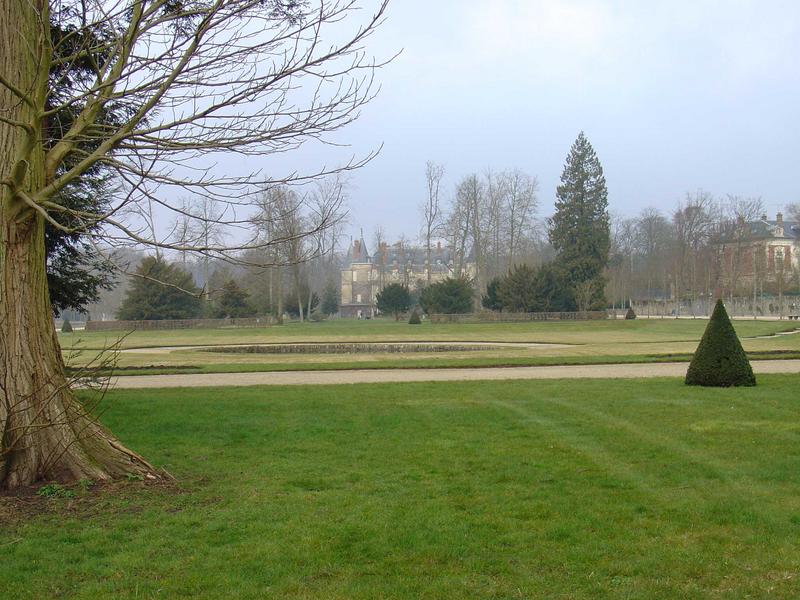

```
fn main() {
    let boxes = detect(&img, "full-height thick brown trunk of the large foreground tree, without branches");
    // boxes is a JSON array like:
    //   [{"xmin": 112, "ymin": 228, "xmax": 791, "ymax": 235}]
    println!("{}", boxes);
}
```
[{"xmin": 0, "ymin": 0, "xmax": 155, "ymax": 489}]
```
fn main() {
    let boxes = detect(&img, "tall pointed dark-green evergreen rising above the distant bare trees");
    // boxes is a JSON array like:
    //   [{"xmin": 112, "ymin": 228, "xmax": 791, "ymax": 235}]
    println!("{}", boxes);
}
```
[{"xmin": 549, "ymin": 132, "xmax": 611, "ymax": 308}]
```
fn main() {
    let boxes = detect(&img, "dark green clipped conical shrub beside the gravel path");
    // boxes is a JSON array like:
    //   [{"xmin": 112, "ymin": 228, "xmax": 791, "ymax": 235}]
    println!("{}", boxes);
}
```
[{"xmin": 686, "ymin": 300, "xmax": 756, "ymax": 387}]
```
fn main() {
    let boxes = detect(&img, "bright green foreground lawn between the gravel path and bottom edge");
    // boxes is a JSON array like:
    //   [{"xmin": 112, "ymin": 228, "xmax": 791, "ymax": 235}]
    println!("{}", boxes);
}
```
[{"xmin": 0, "ymin": 376, "xmax": 800, "ymax": 599}]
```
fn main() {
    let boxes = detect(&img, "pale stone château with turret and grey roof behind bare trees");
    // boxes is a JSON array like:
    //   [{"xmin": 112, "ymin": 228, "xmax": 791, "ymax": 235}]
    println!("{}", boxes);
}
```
[{"xmin": 339, "ymin": 237, "xmax": 475, "ymax": 318}]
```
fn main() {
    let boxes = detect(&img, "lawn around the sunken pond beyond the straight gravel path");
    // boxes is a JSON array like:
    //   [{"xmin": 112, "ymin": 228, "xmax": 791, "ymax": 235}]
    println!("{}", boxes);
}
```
[{"xmin": 60, "ymin": 319, "xmax": 800, "ymax": 373}]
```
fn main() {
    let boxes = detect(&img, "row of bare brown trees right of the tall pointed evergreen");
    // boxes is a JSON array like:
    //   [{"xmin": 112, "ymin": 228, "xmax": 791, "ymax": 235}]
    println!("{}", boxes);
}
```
[{"xmin": 608, "ymin": 195, "xmax": 800, "ymax": 306}]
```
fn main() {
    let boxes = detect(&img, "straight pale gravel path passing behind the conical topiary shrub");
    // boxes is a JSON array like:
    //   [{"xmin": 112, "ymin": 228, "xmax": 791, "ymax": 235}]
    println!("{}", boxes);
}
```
[{"xmin": 111, "ymin": 360, "xmax": 800, "ymax": 389}]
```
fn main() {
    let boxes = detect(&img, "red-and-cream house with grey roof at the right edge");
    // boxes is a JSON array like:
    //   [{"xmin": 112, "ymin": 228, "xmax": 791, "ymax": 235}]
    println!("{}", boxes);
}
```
[{"xmin": 719, "ymin": 213, "xmax": 800, "ymax": 288}]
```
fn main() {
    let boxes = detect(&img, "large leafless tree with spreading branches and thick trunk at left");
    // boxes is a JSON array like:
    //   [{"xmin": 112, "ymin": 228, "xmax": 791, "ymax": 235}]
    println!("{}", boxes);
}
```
[{"xmin": 0, "ymin": 0, "xmax": 387, "ymax": 488}]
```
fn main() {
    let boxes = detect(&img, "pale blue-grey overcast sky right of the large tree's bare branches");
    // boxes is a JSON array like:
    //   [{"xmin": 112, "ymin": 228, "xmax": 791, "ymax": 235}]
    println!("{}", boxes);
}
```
[{"xmin": 274, "ymin": 0, "xmax": 800, "ymax": 241}]
